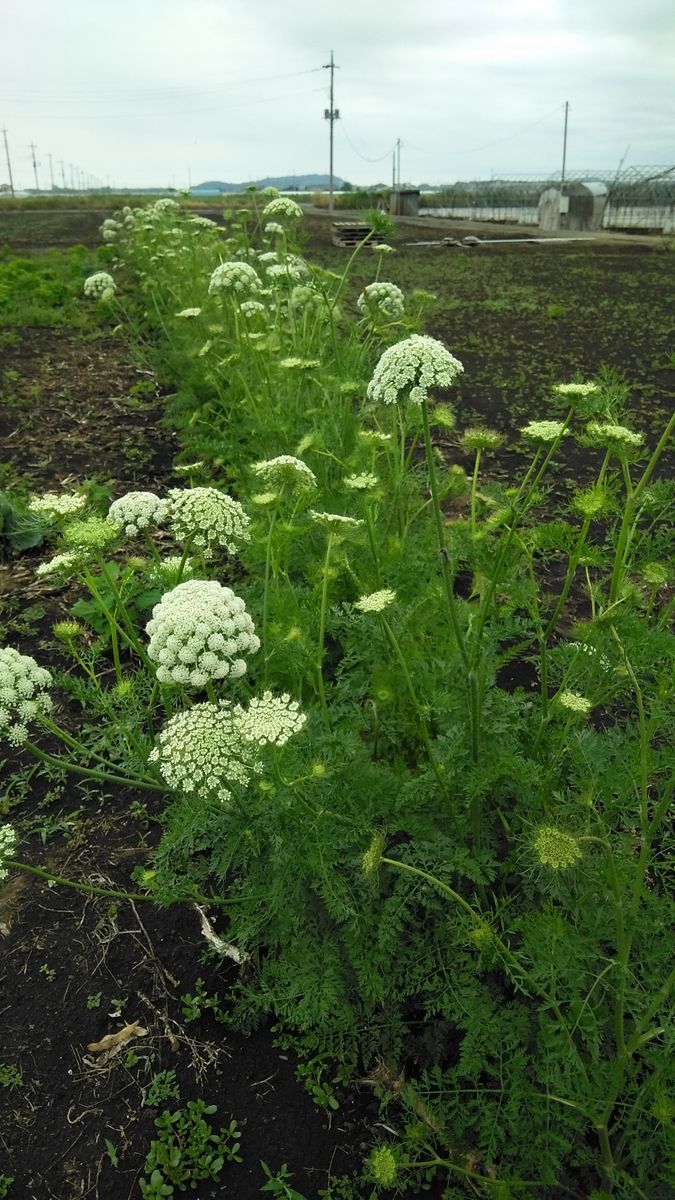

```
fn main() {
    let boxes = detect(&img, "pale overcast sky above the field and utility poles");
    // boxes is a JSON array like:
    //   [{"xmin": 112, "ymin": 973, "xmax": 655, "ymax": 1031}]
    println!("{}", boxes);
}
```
[{"xmin": 0, "ymin": 0, "xmax": 675, "ymax": 187}]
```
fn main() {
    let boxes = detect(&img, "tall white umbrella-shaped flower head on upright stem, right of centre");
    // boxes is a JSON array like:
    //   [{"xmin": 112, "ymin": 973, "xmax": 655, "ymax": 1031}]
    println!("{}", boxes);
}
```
[{"xmin": 368, "ymin": 334, "xmax": 464, "ymax": 404}]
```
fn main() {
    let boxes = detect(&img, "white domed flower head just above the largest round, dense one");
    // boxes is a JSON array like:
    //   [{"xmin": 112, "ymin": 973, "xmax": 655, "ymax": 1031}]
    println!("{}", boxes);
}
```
[{"xmin": 166, "ymin": 487, "xmax": 251, "ymax": 554}]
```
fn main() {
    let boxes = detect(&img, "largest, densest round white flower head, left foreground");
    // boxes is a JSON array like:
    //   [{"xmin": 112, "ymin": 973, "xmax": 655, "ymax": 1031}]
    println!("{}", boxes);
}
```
[{"xmin": 145, "ymin": 580, "xmax": 261, "ymax": 689}]
